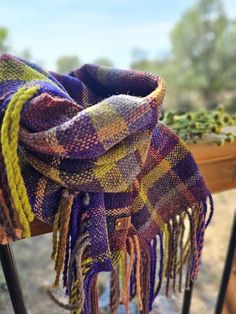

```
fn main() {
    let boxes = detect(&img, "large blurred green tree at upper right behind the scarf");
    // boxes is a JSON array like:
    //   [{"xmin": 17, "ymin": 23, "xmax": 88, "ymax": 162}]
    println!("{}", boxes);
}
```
[{"xmin": 171, "ymin": 0, "xmax": 236, "ymax": 105}]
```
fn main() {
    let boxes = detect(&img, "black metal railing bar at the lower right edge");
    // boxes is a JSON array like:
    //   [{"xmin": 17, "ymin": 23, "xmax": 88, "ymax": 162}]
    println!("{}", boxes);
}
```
[{"xmin": 215, "ymin": 214, "xmax": 236, "ymax": 314}]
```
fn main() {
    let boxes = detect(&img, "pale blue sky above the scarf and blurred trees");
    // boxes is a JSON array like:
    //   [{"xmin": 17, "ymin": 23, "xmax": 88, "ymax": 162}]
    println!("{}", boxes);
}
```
[{"xmin": 0, "ymin": 0, "xmax": 236, "ymax": 70}]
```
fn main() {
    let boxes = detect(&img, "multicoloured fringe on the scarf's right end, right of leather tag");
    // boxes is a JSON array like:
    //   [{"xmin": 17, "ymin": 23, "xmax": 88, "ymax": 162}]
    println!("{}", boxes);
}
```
[{"xmin": 110, "ymin": 196, "xmax": 214, "ymax": 314}]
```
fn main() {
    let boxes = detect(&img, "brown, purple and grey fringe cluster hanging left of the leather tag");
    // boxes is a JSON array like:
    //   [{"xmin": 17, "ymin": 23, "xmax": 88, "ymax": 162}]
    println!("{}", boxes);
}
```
[{"xmin": 48, "ymin": 190, "xmax": 91, "ymax": 314}]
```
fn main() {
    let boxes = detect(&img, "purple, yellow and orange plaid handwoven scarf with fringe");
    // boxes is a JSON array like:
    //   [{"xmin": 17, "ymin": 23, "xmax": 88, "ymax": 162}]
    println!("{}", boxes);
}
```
[{"xmin": 0, "ymin": 54, "xmax": 213, "ymax": 313}]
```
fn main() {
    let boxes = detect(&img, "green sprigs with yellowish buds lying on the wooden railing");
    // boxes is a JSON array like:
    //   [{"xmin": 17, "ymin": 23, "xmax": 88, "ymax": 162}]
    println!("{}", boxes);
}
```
[{"xmin": 162, "ymin": 105, "xmax": 236, "ymax": 145}]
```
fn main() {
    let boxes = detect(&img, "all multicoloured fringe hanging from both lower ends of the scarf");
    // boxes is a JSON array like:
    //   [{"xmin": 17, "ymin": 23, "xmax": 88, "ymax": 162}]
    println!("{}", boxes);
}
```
[{"xmin": 49, "ymin": 193, "xmax": 213, "ymax": 314}]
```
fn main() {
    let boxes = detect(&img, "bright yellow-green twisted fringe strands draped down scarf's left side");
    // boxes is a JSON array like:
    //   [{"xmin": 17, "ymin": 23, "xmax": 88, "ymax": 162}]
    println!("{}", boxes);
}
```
[{"xmin": 1, "ymin": 86, "xmax": 38, "ymax": 237}]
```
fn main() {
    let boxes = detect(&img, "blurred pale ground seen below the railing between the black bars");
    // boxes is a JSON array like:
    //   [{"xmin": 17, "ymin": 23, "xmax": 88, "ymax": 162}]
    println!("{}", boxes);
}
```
[{"xmin": 0, "ymin": 190, "xmax": 236, "ymax": 314}]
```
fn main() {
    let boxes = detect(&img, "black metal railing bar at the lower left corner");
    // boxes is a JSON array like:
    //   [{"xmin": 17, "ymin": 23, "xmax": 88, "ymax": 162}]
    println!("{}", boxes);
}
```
[{"xmin": 0, "ymin": 244, "xmax": 27, "ymax": 314}]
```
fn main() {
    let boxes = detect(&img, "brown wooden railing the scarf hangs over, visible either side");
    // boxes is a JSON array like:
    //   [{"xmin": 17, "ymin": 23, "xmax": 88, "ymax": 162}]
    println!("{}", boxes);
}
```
[{"xmin": 31, "ymin": 143, "xmax": 236, "ymax": 236}]
